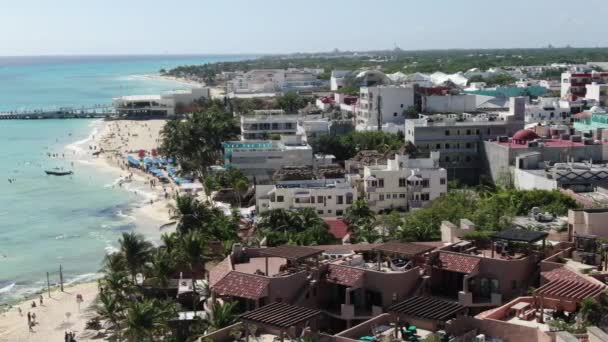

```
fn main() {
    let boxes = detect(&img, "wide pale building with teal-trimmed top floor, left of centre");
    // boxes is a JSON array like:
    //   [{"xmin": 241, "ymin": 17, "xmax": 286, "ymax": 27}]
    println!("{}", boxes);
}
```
[{"xmin": 222, "ymin": 134, "xmax": 313, "ymax": 182}]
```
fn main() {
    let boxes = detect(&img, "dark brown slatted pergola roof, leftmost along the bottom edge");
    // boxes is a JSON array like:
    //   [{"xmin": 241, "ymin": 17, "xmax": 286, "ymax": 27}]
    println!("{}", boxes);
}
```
[{"xmin": 241, "ymin": 302, "xmax": 321, "ymax": 328}]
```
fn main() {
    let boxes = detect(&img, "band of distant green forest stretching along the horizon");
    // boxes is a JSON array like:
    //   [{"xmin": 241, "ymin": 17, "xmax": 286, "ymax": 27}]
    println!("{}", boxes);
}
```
[{"xmin": 165, "ymin": 48, "xmax": 608, "ymax": 84}]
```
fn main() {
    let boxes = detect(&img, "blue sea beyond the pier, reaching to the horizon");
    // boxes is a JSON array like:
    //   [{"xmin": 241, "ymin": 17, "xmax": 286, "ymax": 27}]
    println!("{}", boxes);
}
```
[{"xmin": 0, "ymin": 55, "xmax": 254, "ymax": 112}]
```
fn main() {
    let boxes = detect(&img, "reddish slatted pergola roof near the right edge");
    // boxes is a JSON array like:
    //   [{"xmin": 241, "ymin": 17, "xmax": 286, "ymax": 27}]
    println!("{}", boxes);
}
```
[{"xmin": 534, "ymin": 279, "xmax": 606, "ymax": 301}]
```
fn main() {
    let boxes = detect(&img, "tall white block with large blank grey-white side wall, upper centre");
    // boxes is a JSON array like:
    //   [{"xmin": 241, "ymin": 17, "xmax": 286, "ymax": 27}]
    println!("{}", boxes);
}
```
[{"xmin": 356, "ymin": 86, "xmax": 414, "ymax": 130}]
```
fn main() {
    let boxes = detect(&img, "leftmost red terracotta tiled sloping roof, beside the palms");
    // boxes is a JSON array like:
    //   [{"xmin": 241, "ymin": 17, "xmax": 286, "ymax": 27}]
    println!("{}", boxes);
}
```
[{"xmin": 211, "ymin": 271, "xmax": 270, "ymax": 299}]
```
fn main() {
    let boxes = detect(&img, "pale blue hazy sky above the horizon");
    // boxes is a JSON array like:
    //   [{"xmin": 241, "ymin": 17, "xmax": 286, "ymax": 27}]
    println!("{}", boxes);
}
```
[{"xmin": 0, "ymin": 0, "xmax": 608, "ymax": 56}]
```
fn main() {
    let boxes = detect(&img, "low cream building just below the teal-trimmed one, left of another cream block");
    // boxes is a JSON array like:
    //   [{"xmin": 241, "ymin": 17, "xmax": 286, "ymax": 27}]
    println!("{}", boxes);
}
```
[{"xmin": 256, "ymin": 179, "xmax": 357, "ymax": 217}]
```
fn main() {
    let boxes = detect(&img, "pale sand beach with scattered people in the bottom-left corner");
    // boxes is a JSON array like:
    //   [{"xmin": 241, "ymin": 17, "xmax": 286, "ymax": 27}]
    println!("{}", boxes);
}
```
[{"xmin": 0, "ymin": 282, "xmax": 99, "ymax": 342}]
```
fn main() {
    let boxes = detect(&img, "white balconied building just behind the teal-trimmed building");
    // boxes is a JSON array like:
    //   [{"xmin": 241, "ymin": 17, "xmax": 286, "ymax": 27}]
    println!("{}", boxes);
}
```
[{"xmin": 241, "ymin": 109, "xmax": 299, "ymax": 140}]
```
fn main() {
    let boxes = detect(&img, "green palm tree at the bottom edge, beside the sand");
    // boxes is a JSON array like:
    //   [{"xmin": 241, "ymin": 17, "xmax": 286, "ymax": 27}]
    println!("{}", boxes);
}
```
[{"xmin": 124, "ymin": 299, "xmax": 177, "ymax": 342}]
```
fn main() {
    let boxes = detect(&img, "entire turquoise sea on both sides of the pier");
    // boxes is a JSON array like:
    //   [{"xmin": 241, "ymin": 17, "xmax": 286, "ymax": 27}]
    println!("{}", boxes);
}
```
[{"xmin": 0, "ymin": 56, "xmax": 248, "ymax": 304}]
